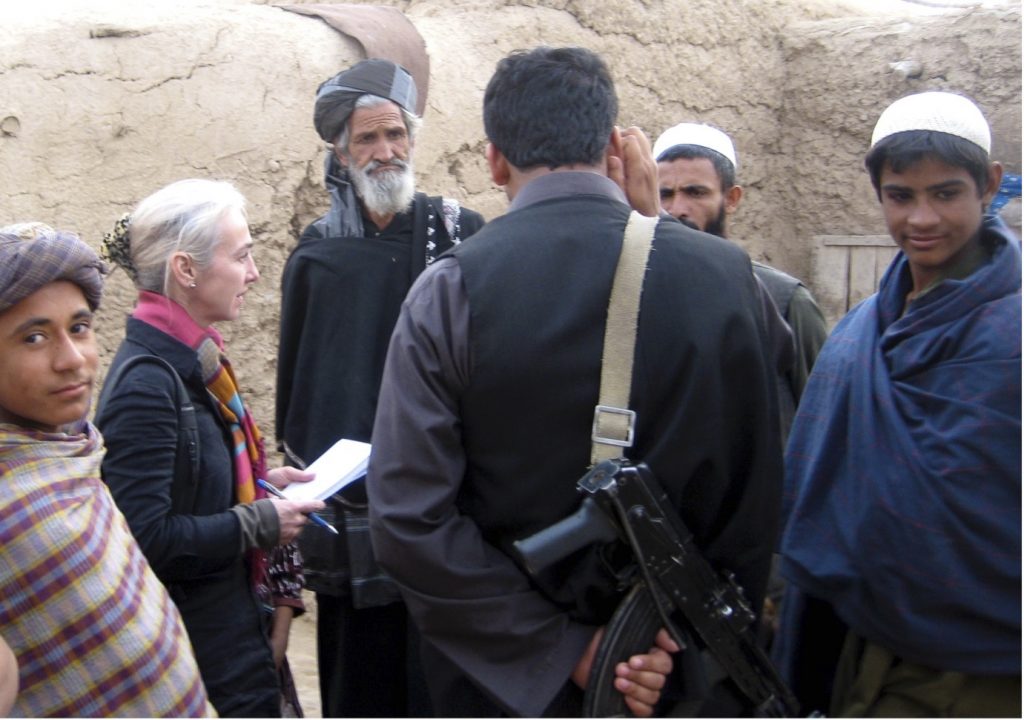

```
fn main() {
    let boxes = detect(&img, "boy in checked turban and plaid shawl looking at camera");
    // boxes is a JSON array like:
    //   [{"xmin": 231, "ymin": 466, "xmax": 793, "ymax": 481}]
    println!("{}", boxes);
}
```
[{"xmin": 0, "ymin": 223, "xmax": 213, "ymax": 717}]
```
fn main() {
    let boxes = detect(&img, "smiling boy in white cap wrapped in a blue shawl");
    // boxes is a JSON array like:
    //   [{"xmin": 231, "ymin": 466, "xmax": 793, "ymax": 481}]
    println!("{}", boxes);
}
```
[{"xmin": 775, "ymin": 92, "xmax": 1021, "ymax": 717}]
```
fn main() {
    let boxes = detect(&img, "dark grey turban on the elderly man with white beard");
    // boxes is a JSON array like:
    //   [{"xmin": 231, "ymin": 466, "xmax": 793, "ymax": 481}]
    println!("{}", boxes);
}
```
[{"xmin": 313, "ymin": 58, "xmax": 416, "ymax": 142}]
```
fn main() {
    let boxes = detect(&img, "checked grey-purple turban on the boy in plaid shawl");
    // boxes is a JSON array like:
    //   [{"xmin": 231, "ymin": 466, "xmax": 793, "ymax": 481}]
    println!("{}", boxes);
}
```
[{"xmin": 0, "ymin": 223, "xmax": 106, "ymax": 312}]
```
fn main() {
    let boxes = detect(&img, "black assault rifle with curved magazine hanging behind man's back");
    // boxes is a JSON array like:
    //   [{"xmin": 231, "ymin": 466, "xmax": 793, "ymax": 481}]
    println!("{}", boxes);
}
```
[{"xmin": 514, "ymin": 459, "xmax": 798, "ymax": 717}]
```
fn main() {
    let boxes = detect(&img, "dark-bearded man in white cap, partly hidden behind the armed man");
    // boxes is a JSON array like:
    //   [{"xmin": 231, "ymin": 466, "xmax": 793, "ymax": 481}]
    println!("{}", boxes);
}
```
[{"xmin": 654, "ymin": 123, "xmax": 828, "ymax": 439}]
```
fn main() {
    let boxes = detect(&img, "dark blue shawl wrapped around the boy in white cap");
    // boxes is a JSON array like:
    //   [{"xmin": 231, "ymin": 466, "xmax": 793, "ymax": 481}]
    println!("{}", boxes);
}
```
[{"xmin": 782, "ymin": 218, "xmax": 1021, "ymax": 674}]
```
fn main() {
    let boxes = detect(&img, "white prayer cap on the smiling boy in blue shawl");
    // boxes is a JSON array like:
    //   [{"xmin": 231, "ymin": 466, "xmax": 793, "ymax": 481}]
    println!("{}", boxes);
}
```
[{"xmin": 871, "ymin": 92, "xmax": 992, "ymax": 153}]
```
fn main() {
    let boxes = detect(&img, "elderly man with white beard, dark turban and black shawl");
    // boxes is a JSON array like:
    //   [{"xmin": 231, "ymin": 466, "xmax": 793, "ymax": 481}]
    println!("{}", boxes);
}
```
[{"xmin": 276, "ymin": 59, "xmax": 483, "ymax": 717}]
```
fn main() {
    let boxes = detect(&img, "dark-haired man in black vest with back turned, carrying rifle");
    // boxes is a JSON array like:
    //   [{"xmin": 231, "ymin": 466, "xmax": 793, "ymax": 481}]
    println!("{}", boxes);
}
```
[{"xmin": 368, "ymin": 47, "xmax": 781, "ymax": 717}]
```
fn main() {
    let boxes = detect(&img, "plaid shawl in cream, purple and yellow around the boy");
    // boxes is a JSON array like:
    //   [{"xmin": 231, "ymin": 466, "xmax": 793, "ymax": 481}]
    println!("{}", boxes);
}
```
[{"xmin": 0, "ymin": 425, "xmax": 214, "ymax": 717}]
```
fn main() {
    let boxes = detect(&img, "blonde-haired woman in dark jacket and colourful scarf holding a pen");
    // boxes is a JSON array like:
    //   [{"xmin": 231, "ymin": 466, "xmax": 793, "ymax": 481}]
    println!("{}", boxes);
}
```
[{"xmin": 96, "ymin": 179, "xmax": 323, "ymax": 717}]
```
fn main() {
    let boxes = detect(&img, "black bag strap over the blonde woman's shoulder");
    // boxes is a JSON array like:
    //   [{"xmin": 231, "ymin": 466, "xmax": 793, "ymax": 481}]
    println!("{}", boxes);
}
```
[{"xmin": 96, "ymin": 354, "xmax": 199, "ymax": 515}]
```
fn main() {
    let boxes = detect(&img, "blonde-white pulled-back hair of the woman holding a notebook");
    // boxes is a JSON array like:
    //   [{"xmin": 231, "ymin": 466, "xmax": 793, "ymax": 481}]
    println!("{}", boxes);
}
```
[{"xmin": 128, "ymin": 179, "xmax": 246, "ymax": 295}]
